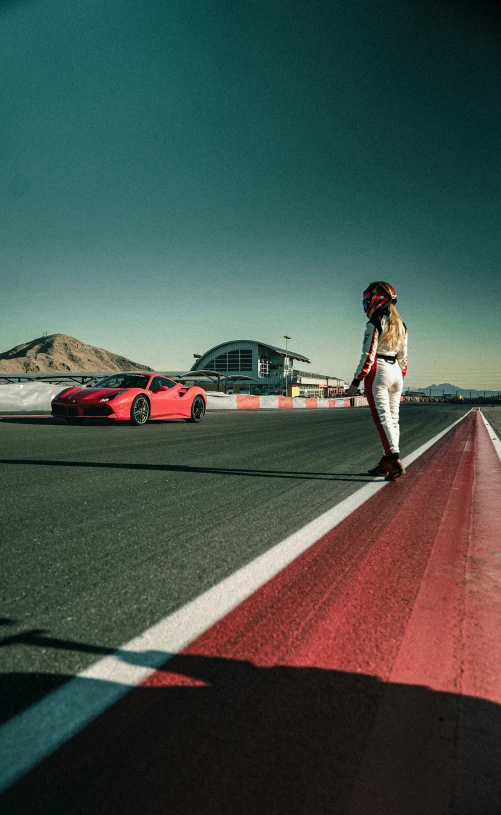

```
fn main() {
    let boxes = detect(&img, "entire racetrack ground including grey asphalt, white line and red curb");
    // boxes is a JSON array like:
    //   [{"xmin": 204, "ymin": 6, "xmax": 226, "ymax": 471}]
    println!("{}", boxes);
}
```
[{"xmin": 0, "ymin": 405, "xmax": 501, "ymax": 815}]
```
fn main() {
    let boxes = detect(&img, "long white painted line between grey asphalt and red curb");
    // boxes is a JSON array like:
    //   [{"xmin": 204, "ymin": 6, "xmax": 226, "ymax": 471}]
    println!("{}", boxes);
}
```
[{"xmin": 0, "ymin": 414, "xmax": 468, "ymax": 792}]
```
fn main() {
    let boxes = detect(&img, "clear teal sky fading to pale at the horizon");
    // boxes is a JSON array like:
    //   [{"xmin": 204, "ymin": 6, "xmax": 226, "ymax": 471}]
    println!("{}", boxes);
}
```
[{"xmin": 0, "ymin": 0, "xmax": 501, "ymax": 389}]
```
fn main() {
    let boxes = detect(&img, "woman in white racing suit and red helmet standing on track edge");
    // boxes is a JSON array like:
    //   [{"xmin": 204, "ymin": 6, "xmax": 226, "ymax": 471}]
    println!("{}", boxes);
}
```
[{"xmin": 348, "ymin": 281, "xmax": 407, "ymax": 481}]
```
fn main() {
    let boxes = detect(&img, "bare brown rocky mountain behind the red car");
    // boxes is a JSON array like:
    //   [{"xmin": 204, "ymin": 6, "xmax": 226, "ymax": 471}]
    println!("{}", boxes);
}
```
[{"xmin": 0, "ymin": 334, "xmax": 153, "ymax": 373}]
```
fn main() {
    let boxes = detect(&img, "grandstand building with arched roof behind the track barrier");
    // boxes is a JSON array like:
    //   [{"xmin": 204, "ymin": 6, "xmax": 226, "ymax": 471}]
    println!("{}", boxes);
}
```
[{"xmin": 191, "ymin": 340, "xmax": 345, "ymax": 396}]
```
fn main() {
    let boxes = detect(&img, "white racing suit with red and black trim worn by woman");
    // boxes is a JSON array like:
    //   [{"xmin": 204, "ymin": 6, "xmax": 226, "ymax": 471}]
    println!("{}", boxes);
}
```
[{"xmin": 352, "ymin": 316, "xmax": 407, "ymax": 458}]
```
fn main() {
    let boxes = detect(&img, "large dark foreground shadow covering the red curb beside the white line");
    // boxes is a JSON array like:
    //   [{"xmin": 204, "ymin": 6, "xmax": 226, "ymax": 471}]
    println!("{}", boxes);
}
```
[{"xmin": 0, "ymin": 646, "xmax": 501, "ymax": 815}]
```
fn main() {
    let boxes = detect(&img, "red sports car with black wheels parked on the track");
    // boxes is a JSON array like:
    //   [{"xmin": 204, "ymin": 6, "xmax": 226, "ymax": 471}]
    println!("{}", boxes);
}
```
[{"xmin": 51, "ymin": 373, "xmax": 207, "ymax": 425}]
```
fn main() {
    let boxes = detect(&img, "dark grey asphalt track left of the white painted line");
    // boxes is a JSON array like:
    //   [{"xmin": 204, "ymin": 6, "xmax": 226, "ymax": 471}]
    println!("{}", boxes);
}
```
[{"xmin": 0, "ymin": 405, "xmax": 469, "ymax": 720}]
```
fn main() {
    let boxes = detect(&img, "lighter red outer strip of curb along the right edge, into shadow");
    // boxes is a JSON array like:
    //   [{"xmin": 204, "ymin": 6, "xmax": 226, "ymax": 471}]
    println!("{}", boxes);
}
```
[{"xmin": 342, "ymin": 411, "xmax": 501, "ymax": 814}]
